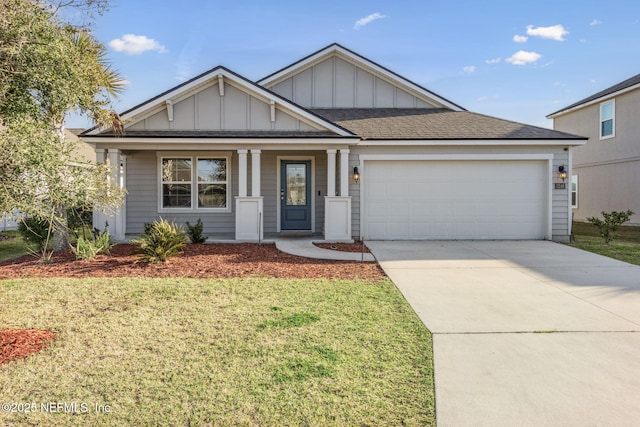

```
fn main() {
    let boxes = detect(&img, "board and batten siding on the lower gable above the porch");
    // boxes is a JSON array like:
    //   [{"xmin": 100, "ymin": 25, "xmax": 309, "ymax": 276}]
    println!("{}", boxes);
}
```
[{"xmin": 126, "ymin": 83, "xmax": 318, "ymax": 131}]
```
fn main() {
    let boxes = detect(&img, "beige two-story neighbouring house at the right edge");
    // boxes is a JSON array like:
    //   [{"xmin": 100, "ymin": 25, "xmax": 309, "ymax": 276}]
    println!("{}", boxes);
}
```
[{"xmin": 547, "ymin": 74, "xmax": 640, "ymax": 225}]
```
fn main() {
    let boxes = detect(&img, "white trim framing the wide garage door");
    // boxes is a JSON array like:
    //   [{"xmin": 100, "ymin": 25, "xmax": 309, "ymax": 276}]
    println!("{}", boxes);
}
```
[{"xmin": 358, "ymin": 154, "xmax": 553, "ymax": 240}]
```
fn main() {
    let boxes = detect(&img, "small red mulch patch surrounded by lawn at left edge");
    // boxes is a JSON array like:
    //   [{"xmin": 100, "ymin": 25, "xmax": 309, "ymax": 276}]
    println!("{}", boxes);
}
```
[{"xmin": 0, "ymin": 329, "xmax": 56, "ymax": 365}]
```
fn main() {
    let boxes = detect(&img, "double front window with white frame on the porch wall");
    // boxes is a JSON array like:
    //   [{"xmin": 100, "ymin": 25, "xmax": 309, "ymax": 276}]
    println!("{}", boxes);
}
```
[{"xmin": 160, "ymin": 156, "xmax": 229, "ymax": 210}]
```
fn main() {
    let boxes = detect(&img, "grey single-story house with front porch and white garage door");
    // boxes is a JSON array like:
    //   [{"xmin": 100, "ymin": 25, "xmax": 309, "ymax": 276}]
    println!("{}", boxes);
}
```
[{"xmin": 83, "ymin": 44, "xmax": 585, "ymax": 241}]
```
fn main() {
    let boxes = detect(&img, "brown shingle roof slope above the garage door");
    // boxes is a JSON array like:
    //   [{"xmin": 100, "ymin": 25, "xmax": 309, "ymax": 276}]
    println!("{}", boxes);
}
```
[{"xmin": 312, "ymin": 108, "xmax": 586, "ymax": 140}]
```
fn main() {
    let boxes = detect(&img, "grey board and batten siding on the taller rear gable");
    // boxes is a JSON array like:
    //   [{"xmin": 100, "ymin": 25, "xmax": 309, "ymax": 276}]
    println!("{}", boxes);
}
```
[{"xmin": 269, "ymin": 56, "xmax": 434, "ymax": 108}]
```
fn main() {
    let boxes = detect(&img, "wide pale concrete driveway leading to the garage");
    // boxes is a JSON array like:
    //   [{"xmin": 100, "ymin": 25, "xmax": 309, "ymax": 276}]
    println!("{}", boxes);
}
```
[{"xmin": 367, "ymin": 241, "xmax": 640, "ymax": 427}]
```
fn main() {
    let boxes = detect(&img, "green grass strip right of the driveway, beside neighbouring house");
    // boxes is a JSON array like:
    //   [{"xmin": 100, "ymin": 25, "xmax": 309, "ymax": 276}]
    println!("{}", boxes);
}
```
[{"xmin": 572, "ymin": 222, "xmax": 640, "ymax": 265}]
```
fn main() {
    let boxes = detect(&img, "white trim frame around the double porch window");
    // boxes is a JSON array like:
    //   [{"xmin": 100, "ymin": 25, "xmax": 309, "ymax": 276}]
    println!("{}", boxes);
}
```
[{"xmin": 156, "ymin": 151, "xmax": 233, "ymax": 213}]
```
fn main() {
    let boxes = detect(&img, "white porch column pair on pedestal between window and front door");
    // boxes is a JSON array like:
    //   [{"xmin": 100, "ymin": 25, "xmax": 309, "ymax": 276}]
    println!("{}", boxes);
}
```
[{"xmin": 235, "ymin": 150, "xmax": 264, "ymax": 242}]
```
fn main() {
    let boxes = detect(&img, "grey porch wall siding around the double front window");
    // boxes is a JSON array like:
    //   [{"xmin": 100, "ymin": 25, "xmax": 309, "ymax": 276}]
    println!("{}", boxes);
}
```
[{"xmin": 126, "ymin": 151, "xmax": 238, "ymax": 238}]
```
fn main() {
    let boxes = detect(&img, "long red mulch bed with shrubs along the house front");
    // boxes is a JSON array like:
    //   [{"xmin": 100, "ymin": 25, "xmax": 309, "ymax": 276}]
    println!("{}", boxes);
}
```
[{"xmin": 0, "ymin": 243, "xmax": 385, "ymax": 280}]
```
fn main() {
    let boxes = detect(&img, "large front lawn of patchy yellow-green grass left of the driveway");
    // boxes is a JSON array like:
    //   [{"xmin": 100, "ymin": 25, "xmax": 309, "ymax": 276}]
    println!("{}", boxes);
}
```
[{"xmin": 0, "ymin": 278, "xmax": 435, "ymax": 426}]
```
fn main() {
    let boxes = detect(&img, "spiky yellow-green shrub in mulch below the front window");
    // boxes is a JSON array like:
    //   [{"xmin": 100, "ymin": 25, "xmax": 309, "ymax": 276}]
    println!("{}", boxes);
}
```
[{"xmin": 131, "ymin": 218, "xmax": 188, "ymax": 264}]
